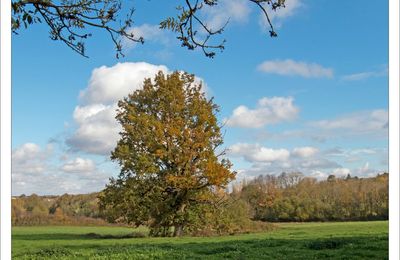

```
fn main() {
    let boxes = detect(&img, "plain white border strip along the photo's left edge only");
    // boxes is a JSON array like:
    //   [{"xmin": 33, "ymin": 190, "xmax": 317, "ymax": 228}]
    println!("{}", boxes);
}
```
[{"xmin": 0, "ymin": 0, "xmax": 11, "ymax": 259}]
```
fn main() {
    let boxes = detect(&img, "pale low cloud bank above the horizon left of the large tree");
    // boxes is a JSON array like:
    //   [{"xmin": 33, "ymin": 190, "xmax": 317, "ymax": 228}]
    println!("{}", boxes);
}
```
[{"xmin": 12, "ymin": 143, "xmax": 111, "ymax": 195}]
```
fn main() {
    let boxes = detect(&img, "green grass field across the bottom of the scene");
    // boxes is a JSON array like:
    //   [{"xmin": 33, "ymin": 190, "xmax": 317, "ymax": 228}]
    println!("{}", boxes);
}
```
[{"xmin": 12, "ymin": 221, "xmax": 388, "ymax": 259}]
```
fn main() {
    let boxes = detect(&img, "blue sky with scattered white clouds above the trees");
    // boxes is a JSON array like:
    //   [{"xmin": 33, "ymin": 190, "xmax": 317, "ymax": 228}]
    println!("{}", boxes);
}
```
[{"xmin": 12, "ymin": 0, "xmax": 388, "ymax": 195}]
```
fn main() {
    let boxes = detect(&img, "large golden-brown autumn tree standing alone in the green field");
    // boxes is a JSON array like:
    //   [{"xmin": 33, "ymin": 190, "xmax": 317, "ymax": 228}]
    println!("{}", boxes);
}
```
[{"xmin": 100, "ymin": 72, "xmax": 235, "ymax": 236}]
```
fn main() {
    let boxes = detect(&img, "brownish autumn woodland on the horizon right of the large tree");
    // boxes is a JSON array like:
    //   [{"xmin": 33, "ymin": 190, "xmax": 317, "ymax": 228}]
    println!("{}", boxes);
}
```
[{"xmin": 231, "ymin": 173, "xmax": 389, "ymax": 222}]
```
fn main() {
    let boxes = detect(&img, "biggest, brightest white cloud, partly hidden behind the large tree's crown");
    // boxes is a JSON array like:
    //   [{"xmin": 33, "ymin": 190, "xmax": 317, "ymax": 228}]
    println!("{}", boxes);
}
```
[{"xmin": 66, "ymin": 62, "xmax": 207, "ymax": 156}]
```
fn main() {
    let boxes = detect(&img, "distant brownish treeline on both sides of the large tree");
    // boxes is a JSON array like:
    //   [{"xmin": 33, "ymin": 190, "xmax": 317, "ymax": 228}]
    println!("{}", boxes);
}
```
[{"xmin": 12, "ymin": 173, "xmax": 389, "ymax": 226}]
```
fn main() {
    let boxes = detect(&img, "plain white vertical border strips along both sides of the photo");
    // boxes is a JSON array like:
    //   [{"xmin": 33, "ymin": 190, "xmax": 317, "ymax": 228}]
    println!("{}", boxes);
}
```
[{"xmin": 0, "ymin": 0, "xmax": 400, "ymax": 259}]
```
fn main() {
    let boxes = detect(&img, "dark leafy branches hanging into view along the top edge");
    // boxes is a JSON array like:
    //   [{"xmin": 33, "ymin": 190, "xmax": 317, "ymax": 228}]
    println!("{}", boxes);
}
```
[{"xmin": 11, "ymin": 0, "xmax": 285, "ymax": 58}]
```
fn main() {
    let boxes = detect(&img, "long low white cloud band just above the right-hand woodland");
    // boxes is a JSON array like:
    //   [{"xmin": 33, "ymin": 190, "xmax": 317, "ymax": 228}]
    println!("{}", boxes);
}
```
[{"xmin": 227, "ymin": 143, "xmax": 386, "ymax": 180}]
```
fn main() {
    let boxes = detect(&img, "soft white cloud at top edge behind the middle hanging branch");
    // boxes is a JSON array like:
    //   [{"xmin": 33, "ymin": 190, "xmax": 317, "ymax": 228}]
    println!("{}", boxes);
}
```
[{"xmin": 202, "ymin": 0, "xmax": 251, "ymax": 30}]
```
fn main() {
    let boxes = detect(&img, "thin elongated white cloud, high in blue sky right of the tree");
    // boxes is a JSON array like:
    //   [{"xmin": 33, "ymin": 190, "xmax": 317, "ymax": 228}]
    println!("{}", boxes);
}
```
[{"xmin": 257, "ymin": 59, "xmax": 333, "ymax": 78}]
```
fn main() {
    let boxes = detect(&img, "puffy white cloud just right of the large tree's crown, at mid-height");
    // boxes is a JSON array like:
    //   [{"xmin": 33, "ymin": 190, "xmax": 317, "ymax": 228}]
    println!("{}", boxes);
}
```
[{"xmin": 225, "ymin": 97, "xmax": 299, "ymax": 128}]
